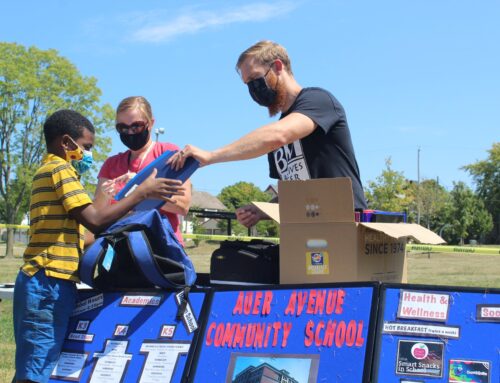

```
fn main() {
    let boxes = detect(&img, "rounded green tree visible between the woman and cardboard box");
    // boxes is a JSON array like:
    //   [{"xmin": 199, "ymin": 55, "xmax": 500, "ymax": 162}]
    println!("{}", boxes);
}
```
[{"xmin": 217, "ymin": 181, "xmax": 278, "ymax": 237}]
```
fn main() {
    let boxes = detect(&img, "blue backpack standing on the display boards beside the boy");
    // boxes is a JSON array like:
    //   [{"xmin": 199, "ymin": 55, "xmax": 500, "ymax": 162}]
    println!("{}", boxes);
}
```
[{"xmin": 80, "ymin": 209, "xmax": 196, "ymax": 290}]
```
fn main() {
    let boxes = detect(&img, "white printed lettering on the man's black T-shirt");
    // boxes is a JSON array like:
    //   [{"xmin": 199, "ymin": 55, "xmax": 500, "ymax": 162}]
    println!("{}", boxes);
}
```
[{"xmin": 273, "ymin": 140, "xmax": 311, "ymax": 181}]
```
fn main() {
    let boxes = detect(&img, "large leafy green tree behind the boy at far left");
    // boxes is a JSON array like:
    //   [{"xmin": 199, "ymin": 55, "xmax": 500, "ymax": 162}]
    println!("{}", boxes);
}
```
[{"xmin": 0, "ymin": 43, "xmax": 113, "ymax": 256}]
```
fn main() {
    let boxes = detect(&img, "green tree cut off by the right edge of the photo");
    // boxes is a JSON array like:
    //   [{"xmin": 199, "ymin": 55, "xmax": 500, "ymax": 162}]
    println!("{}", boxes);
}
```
[{"xmin": 463, "ymin": 142, "xmax": 500, "ymax": 243}]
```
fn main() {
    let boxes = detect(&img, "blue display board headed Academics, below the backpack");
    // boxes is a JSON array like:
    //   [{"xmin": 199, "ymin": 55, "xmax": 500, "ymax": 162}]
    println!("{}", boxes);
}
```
[{"xmin": 50, "ymin": 290, "xmax": 206, "ymax": 383}]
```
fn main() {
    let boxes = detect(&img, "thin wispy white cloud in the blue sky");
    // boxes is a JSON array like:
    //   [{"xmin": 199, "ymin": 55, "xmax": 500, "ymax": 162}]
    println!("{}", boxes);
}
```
[{"xmin": 131, "ymin": 2, "xmax": 296, "ymax": 43}]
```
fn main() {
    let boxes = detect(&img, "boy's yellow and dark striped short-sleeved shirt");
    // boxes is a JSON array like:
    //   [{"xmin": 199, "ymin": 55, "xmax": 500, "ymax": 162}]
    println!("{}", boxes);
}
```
[{"xmin": 21, "ymin": 154, "xmax": 92, "ymax": 282}]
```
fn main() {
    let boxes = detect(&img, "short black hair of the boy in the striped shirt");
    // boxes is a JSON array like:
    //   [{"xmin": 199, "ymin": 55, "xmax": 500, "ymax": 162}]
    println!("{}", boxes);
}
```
[{"xmin": 43, "ymin": 109, "xmax": 95, "ymax": 145}]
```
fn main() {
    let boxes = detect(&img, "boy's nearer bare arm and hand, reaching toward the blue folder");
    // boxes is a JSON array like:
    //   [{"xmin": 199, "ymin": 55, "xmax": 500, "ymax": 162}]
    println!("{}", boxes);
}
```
[{"xmin": 69, "ymin": 169, "xmax": 182, "ymax": 233}]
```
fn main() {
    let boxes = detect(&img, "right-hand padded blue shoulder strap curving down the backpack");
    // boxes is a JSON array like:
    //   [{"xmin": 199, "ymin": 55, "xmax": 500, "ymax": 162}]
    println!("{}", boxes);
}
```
[{"xmin": 127, "ymin": 230, "xmax": 184, "ymax": 289}]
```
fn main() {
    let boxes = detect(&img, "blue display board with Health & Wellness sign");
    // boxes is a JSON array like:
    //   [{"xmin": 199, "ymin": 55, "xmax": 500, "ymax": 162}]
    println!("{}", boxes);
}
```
[{"xmin": 373, "ymin": 285, "xmax": 500, "ymax": 383}]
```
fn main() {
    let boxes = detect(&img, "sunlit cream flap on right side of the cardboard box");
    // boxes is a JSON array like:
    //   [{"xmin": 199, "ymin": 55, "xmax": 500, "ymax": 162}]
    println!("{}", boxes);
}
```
[{"xmin": 360, "ymin": 222, "xmax": 446, "ymax": 245}]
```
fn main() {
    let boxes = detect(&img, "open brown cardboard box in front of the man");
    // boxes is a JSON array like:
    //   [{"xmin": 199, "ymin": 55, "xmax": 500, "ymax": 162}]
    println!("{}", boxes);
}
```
[{"xmin": 254, "ymin": 178, "xmax": 445, "ymax": 284}]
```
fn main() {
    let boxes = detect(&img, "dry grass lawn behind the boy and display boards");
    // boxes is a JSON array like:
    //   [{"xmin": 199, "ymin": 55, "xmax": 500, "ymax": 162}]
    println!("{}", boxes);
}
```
[{"xmin": 0, "ymin": 241, "xmax": 500, "ymax": 383}]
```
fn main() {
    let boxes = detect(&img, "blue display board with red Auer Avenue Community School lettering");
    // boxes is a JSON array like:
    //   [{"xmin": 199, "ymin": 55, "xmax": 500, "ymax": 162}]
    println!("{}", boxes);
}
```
[{"xmin": 189, "ymin": 283, "xmax": 378, "ymax": 383}]
